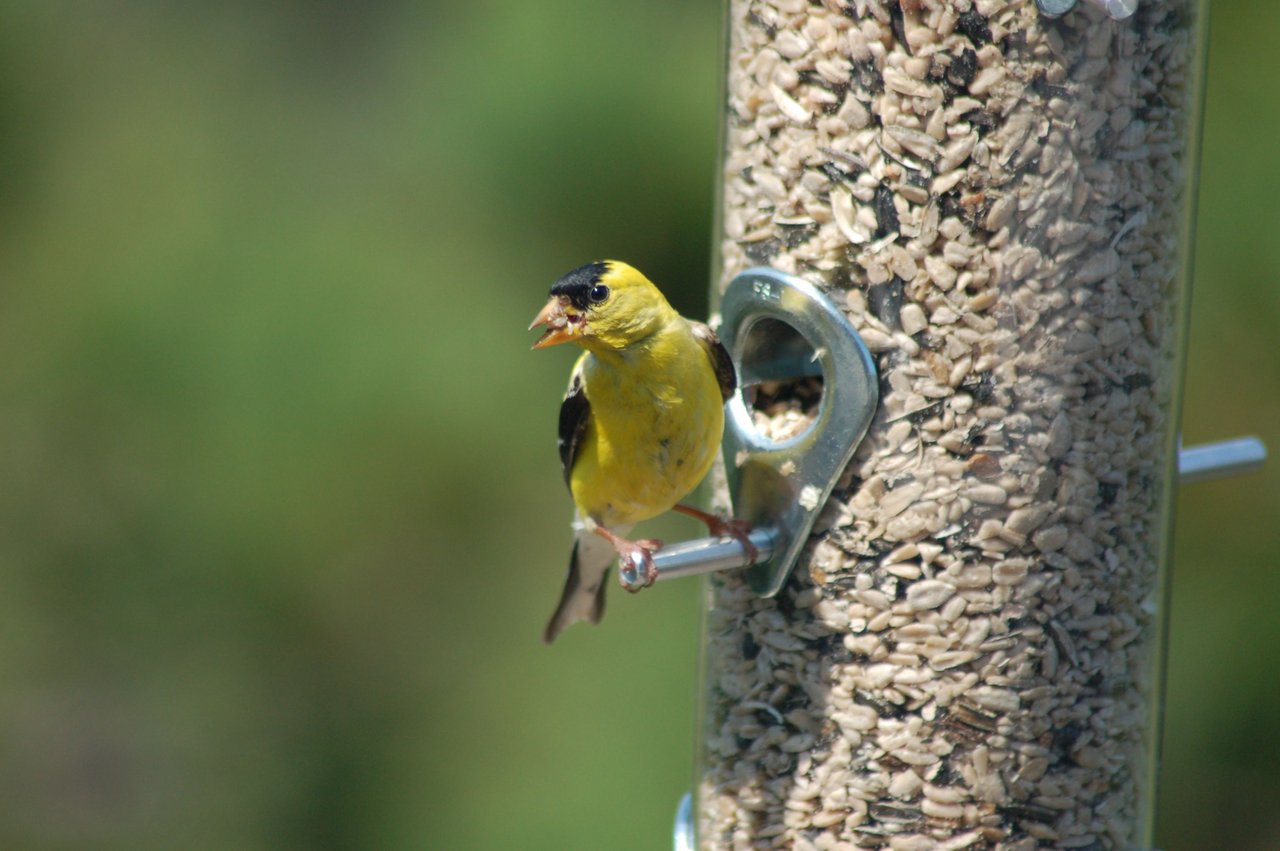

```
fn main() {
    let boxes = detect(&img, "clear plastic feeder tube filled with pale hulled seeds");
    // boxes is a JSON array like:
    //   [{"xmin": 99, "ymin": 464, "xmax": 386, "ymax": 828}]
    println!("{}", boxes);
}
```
[{"xmin": 695, "ymin": 0, "xmax": 1204, "ymax": 851}]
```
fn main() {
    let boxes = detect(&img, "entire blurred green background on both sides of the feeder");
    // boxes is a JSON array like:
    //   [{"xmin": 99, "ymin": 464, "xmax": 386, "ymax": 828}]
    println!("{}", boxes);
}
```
[{"xmin": 0, "ymin": 0, "xmax": 1280, "ymax": 851}]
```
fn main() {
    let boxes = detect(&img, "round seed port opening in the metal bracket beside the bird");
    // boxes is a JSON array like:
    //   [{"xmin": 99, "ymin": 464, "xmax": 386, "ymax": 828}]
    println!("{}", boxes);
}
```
[{"xmin": 740, "ymin": 317, "xmax": 823, "ymax": 443}]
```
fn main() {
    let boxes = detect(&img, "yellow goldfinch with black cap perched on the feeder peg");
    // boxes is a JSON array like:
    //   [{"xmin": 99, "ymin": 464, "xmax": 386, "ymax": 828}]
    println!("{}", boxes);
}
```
[{"xmin": 529, "ymin": 260, "xmax": 754, "ymax": 644}]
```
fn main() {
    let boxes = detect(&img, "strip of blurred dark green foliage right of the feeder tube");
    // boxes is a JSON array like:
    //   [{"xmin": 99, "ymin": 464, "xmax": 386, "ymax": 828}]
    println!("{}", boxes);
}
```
[{"xmin": 1156, "ymin": 0, "xmax": 1280, "ymax": 851}]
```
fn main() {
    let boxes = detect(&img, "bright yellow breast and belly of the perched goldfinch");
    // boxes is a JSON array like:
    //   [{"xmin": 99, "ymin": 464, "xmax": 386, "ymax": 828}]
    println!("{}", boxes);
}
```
[{"xmin": 570, "ymin": 320, "xmax": 724, "ymax": 526}]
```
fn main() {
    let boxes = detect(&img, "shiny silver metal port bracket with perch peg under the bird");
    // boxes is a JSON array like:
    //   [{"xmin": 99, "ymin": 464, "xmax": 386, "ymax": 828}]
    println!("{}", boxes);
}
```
[{"xmin": 620, "ymin": 267, "xmax": 879, "ymax": 596}]
